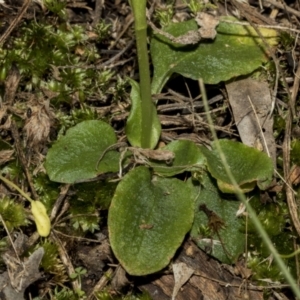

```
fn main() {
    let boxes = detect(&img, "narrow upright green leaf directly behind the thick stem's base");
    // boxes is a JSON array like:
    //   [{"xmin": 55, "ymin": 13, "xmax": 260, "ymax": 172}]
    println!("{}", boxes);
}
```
[{"xmin": 126, "ymin": 79, "xmax": 161, "ymax": 149}]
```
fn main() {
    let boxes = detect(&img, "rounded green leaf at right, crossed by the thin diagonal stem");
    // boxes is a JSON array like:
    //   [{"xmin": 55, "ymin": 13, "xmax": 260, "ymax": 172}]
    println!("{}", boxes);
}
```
[{"xmin": 201, "ymin": 139, "xmax": 273, "ymax": 193}]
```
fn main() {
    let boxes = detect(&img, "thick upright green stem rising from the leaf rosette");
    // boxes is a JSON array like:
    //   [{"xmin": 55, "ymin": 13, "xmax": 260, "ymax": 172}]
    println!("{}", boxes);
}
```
[{"xmin": 130, "ymin": 0, "xmax": 153, "ymax": 148}]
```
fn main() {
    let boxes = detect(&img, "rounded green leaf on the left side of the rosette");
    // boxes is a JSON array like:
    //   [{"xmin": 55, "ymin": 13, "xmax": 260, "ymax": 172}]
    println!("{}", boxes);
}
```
[{"xmin": 45, "ymin": 120, "xmax": 120, "ymax": 183}]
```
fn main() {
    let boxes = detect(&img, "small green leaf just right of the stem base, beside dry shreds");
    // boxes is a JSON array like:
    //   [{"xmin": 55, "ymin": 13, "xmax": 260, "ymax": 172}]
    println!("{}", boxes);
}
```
[{"xmin": 150, "ymin": 140, "xmax": 205, "ymax": 177}]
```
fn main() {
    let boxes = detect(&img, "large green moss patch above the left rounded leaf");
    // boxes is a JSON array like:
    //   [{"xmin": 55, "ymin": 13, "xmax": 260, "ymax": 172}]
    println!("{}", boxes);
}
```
[{"xmin": 0, "ymin": 17, "xmax": 114, "ymax": 103}]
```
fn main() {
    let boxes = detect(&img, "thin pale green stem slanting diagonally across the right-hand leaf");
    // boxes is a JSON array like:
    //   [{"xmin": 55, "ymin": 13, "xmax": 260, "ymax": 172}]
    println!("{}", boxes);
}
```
[{"xmin": 199, "ymin": 79, "xmax": 300, "ymax": 299}]
